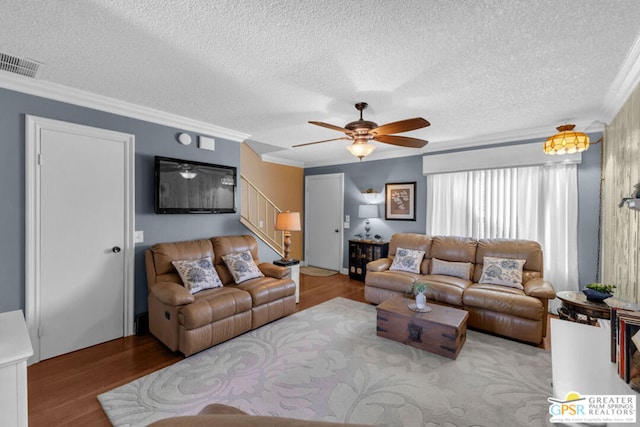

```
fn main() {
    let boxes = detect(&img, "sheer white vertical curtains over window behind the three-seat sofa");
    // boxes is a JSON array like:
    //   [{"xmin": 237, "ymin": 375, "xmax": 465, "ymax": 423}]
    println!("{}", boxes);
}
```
[{"xmin": 426, "ymin": 164, "xmax": 578, "ymax": 313}]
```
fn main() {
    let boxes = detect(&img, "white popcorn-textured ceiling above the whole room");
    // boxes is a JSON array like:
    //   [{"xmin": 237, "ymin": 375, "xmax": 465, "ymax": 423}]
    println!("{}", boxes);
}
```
[{"xmin": 0, "ymin": 0, "xmax": 640, "ymax": 166}]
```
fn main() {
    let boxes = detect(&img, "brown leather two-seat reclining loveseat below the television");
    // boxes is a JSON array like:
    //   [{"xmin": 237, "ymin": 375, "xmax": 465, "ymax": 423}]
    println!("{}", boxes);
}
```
[{"xmin": 145, "ymin": 235, "xmax": 296, "ymax": 356}]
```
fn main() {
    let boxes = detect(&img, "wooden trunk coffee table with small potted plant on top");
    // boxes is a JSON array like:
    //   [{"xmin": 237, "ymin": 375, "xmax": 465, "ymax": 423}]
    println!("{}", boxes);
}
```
[{"xmin": 377, "ymin": 297, "xmax": 469, "ymax": 359}]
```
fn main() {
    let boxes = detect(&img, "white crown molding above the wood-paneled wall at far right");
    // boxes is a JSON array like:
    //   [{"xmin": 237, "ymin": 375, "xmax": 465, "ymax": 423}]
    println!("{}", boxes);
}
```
[{"xmin": 603, "ymin": 31, "xmax": 640, "ymax": 123}]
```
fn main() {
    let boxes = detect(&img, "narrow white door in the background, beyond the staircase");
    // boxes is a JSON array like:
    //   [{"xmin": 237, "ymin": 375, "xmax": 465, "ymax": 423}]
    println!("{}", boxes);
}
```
[{"xmin": 304, "ymin": 173, "xmax": 344, "ymax": 271}]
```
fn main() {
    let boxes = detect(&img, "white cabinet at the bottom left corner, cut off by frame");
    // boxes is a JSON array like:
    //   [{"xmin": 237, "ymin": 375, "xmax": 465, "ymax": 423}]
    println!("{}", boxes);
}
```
[{"xmin": 0, "ymin": 310, "xmax": 33, "ymax": 426}]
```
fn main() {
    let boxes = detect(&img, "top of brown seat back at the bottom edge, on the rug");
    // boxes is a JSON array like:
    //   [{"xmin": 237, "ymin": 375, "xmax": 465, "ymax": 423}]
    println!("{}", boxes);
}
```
[{"xmin": 149, "ymin": 403, "xmax": 371, "ymax": 427}]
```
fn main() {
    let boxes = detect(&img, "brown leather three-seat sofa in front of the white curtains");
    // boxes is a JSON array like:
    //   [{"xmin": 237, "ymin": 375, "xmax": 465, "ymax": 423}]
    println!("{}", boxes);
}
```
[{"xmin": 364, "ymin": 233, "xmax": 556, "ymax": 344}]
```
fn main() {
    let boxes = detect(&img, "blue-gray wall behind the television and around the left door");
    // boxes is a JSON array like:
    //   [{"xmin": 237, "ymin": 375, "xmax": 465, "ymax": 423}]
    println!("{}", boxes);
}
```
[{"xmin": 0, "ymin": 88, "xmax": 277, "ymax": 313}]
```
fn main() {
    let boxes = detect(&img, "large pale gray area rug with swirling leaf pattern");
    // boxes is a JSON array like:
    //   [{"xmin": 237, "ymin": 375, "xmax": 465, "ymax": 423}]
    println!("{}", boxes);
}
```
[{"xmin": 98, "ymin": 298, "xmax": 552, "ymax": 426}]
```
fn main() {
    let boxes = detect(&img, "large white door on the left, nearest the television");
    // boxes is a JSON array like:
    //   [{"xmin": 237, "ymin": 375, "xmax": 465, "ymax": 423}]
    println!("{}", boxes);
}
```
[{"xmin": 27, "ymin": 115, "xmax": 133, "ymax": 360}]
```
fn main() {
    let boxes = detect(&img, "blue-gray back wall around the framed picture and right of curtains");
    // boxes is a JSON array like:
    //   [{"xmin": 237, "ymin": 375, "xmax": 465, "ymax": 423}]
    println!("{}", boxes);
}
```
[{"xmin": 305, "ymin": 133, "xmax": 602, "ymax": 289}]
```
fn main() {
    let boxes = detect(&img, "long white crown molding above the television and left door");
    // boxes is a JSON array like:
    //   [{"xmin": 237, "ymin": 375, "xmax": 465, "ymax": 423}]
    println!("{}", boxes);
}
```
[{"xmin": 0, "ymin": 71, "xmax": 251, "ymax": 142}]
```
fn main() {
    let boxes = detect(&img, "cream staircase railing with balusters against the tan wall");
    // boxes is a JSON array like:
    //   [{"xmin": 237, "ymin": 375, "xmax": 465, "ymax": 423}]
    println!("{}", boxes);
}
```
[{"xmin": 240, "ymin": 174, "xmax": 284, "ymax": 256}]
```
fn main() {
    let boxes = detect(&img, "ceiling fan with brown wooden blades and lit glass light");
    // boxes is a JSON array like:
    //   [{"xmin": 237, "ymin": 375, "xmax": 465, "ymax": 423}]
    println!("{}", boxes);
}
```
[{"xmin": 294, "ymin": 102, "xmax": 431, "ymax": 160}]
